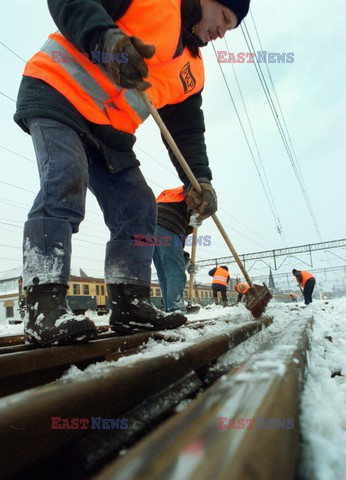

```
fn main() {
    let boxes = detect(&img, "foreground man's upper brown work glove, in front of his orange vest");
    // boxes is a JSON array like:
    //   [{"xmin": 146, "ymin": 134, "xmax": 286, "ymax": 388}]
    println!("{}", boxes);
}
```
[{"xmin": 103, "ymin": 29, "xmax": 155, "ymax": 90}]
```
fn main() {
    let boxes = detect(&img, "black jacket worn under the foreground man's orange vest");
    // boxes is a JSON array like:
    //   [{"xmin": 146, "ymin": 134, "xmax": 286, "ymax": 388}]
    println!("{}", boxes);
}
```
[{"xmin": 14, "ymin": 0, "xmax": 212, "ymax": 185}]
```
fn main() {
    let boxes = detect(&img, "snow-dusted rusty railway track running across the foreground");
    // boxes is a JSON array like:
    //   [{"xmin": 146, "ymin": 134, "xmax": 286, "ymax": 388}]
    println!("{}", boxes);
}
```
[{"xmin": 0, "ymin": 317, "xmax": 310, "ymax": 480}]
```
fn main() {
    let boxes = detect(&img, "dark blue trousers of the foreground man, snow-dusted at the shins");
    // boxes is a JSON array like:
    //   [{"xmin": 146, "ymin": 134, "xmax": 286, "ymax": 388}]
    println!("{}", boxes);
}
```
[{"xmin": 23, "ymin": 118, "xmax": 156, "ymax": 286}]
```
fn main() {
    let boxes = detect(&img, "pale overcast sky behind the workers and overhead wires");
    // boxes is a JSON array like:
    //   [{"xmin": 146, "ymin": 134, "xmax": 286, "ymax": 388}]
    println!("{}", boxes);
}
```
[{"xmin": 0, "ymin": 0, "xmax": 346, "ymax": 290}]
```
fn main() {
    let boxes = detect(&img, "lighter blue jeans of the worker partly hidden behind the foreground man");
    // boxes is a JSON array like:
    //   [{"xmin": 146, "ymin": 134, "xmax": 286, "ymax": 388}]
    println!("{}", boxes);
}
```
[{"xmin": 153, "ymin": 225, "xmax": 186, "ymax": 312}]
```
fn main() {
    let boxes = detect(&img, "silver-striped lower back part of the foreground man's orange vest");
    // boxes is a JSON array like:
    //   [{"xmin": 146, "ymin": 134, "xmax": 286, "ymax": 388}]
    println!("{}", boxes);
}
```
[{"xmin": 24, "ymin": 33, "xmax": 149, "ymax": 133}]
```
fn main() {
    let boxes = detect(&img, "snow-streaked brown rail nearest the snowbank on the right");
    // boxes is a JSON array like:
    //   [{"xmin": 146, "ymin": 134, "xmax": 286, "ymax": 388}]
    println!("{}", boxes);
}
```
[{"xmin": 93, "ymin": 319, "xmax": 312, "ymax": 480}]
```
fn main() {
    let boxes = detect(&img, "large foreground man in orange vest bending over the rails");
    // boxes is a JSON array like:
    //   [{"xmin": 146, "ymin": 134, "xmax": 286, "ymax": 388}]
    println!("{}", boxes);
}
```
[{"xmin": 14, "ymin": 0, "xmax": 250, "ymax": 345}]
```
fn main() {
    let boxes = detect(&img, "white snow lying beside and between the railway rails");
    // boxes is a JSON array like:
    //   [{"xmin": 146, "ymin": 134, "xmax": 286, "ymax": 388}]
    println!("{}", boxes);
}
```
[{"xmin": 0, "ymin": 298, "xmax": 346, "ymax": 480}]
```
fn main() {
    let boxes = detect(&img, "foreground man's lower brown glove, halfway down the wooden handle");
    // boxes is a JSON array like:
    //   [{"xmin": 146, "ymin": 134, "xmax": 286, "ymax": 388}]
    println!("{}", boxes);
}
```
[{"xmin": 184, "ymin": 178, "xmax": 217, "ymax": 221}]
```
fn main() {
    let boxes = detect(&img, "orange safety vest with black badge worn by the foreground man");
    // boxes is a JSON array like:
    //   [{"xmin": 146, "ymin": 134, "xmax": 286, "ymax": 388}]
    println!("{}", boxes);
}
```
[{"xmin": 24, "ymin": 0, "xmax": 204, "ymax": 133}]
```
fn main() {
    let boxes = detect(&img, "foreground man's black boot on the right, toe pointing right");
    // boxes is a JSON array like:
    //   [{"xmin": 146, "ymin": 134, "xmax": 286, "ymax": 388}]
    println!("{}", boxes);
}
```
[{"xmin": 107, "ymin": 284, "xmax": 187, "ymax": 335}]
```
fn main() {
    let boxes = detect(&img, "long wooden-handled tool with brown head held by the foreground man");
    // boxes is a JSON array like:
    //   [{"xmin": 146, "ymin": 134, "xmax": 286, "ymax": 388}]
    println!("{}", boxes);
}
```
[{"xmin": 138, "ymin": 91, "xmax": 273, "ymax": 318}]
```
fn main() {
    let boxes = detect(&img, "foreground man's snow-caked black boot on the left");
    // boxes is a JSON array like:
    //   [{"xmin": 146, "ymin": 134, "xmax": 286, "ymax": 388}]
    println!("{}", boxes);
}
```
[{"xmin": 24, "ymin": 284, "xmax": 97, "ymax": 346}]
